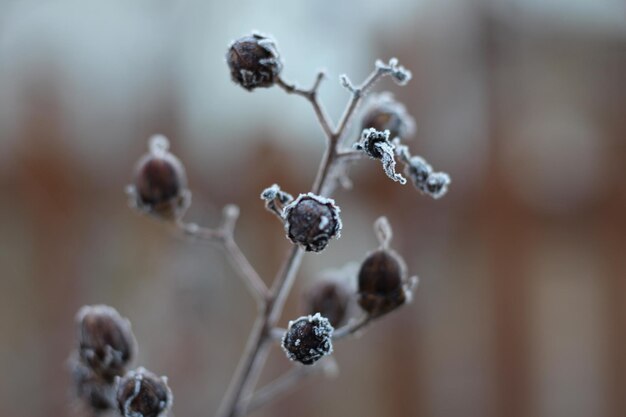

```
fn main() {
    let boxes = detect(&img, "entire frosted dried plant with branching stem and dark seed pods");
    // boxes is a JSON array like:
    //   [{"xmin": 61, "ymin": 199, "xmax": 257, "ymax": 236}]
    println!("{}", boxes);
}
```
[{"xmin": 70, "ymin": 33, "xmax": 450, "ymax": 417}]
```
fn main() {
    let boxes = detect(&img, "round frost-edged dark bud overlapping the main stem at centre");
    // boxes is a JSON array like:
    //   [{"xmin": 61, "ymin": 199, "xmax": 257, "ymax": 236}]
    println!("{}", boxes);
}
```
[{"xmin": 283, "ymin": 193, "xmax": 341, "ymax": 252}]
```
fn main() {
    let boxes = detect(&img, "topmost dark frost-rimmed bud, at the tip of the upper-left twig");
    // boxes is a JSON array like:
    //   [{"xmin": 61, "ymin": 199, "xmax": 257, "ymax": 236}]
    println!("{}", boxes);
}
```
[{"xmin": 226, "ymin": 33, "xmax": 283, "ymax": 91}]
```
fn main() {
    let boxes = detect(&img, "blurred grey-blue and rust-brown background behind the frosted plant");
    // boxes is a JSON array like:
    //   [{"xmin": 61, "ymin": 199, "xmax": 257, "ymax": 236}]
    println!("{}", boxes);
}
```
[{"xmin": 0, "ymin": 0, "xmax": 626, "ymax": 417}]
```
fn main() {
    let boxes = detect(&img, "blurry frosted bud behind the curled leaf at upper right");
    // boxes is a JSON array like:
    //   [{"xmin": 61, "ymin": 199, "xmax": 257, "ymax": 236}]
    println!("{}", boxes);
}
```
[{"xmin": 361, "ymin": 92, "xmax": 415, "ymax": 138}]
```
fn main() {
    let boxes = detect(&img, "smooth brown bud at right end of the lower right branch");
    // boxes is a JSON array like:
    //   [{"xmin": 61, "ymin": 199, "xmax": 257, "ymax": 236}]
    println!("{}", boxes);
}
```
[{"xmin": 358, "ymin": 249, "xmax": 407, "ymax": 317}]
